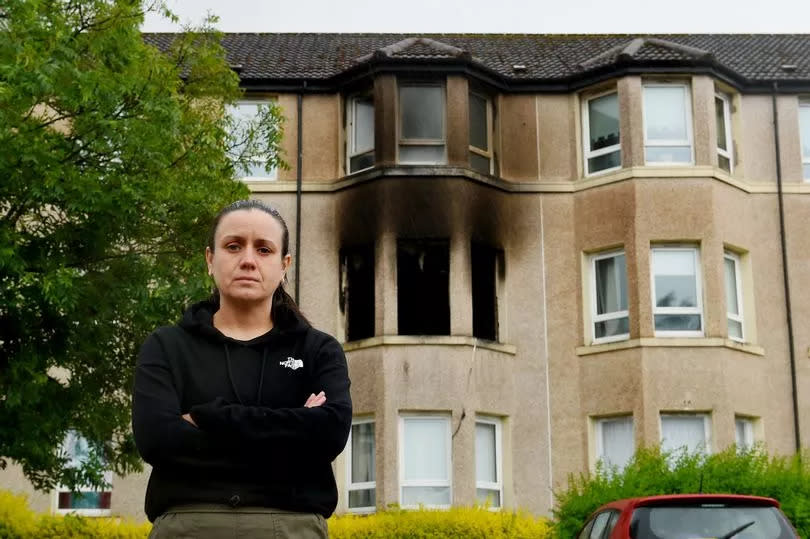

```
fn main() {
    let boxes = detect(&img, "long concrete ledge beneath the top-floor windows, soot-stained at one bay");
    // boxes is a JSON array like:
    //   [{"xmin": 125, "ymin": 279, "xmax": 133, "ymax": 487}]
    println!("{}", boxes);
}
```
[{"xmin": 245, "ymin": 165, "xmax": 810, "ymax": 194}]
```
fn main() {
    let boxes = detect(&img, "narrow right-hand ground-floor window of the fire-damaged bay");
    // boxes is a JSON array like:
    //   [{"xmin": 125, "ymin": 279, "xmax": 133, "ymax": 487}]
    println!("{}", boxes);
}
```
[{"xmin": 475, "ymin": 417, "xmax": 503, "ymax": 508}]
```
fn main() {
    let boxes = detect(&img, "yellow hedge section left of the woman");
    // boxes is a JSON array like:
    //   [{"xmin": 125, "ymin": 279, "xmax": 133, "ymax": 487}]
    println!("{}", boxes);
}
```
[{"xmin": 0, "ymin": 490, "xmax": 152, "ymax": 539}]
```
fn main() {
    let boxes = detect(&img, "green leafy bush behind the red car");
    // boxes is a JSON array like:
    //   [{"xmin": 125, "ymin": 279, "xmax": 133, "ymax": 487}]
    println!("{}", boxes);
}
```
[{"xmin": 554, "ymin": 447, "xmax": 810, "ymax": 537}]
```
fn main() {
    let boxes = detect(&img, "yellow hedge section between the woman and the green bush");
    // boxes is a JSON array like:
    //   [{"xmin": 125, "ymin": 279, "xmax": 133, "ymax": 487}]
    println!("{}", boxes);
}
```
[{"xmin": 329, "ymin": 507, "xmax": 551, "ymax": 539}]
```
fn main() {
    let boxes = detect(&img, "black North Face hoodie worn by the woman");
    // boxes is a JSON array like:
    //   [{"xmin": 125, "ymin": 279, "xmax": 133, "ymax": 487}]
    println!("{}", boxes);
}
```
[{"xmin": 132, "ymin": 302, "xmax": 352, "ymax": 521}]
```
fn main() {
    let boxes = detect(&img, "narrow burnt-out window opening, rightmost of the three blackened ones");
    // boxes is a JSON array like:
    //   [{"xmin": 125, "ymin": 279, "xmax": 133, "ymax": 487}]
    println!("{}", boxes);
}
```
[{"xmin": 470, "ymin": 242, "xmax": 503, "ymax": 341}]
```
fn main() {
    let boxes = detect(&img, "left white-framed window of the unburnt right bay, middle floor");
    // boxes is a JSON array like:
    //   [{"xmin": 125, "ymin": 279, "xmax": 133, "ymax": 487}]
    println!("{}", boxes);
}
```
[{"xmin": 591, "ymin": 251, "xmax": 630, "ymax": 343}]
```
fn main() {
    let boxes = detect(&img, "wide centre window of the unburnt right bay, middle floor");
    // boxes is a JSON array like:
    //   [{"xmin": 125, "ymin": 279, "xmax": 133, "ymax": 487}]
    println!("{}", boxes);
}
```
[{"xmin": 651, "ymin": 247, "xmax": 703, "ymax": 337}]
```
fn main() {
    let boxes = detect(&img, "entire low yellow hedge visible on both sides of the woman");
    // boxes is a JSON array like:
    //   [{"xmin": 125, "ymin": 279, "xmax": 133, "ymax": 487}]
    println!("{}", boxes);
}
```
[{"xmin": 0, "ymin": 490, "xmax": 551, "ymax": 539}]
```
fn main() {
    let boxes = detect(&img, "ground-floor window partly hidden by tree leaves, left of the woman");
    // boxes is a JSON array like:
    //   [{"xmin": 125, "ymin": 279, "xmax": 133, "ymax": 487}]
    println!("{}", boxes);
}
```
[{"xmin": 56, "ymin": 431, "xmax": 112, "ymax": 516}]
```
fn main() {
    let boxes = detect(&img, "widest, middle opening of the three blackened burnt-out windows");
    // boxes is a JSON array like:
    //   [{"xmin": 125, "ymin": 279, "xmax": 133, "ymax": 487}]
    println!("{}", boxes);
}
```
[{"xmin": 397, "ymin": 239, "xmax": 450, "ymax": 335}]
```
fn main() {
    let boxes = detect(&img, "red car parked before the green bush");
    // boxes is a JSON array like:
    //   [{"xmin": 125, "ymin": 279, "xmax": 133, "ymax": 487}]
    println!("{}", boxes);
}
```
[{"xmin": 577, "ymin": 494, "xmax": 799, "ymax": 539}]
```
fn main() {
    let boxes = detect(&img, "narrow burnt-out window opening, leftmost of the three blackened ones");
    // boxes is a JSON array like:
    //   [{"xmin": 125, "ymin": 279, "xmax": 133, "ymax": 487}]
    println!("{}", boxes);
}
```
[{"xmin": 340, "ymin": 244, "xmax": 374, "ymax": 341}]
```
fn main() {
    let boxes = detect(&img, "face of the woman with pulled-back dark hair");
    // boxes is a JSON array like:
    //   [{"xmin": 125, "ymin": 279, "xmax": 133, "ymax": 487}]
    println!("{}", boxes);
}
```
[{"xmin": 205, "ymin": 209, "xmax": 291, "ymax": 303}]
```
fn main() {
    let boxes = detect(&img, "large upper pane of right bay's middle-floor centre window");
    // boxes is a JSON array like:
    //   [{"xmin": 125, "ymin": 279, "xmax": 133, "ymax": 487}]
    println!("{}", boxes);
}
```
[{"xmin": 653, "ymin": 250, "xmax": 697, "ymax": 307}]
